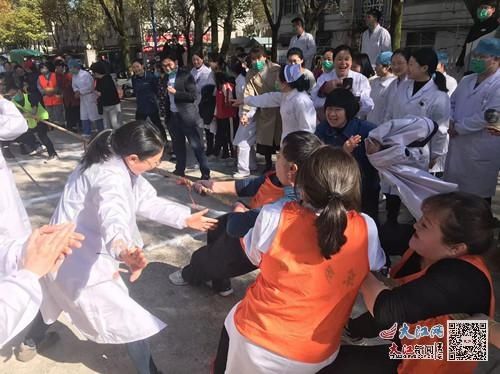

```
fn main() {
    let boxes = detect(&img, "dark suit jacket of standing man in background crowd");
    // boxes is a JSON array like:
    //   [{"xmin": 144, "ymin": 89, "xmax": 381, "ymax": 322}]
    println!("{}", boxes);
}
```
[{"xmin": 165, "ymin": 68, "xmax": 198, "ymax": 126}]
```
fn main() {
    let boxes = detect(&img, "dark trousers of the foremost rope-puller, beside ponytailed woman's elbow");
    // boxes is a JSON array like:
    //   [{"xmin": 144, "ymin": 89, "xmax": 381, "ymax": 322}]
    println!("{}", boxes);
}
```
[{"xmin": 182, "ymin": 214, "xmax": 257, "ymax": 291}]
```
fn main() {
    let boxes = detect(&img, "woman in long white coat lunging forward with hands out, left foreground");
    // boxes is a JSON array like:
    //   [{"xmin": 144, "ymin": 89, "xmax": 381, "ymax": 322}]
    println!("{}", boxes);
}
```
[{"xmin": 21, "ymin": 121, "xmax": 217, "ymax": 374}]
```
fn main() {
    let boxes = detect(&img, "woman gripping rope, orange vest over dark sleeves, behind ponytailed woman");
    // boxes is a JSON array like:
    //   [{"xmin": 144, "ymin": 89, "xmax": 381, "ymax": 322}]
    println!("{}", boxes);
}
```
[{"xmin": 170, "ymin": 131, "xmax": 328, "ymax": 296}]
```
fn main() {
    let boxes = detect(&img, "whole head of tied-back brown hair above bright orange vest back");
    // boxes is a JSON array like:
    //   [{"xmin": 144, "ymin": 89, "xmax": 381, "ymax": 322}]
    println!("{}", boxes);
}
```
[{"xmin": 297, "ymin": 145, "xmax": 361, "ymax": 259}]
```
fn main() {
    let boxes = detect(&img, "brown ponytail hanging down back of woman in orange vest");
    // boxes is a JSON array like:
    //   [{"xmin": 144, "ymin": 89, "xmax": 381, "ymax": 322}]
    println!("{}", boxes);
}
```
[{"xmin": 315, "ymin": 193, "xmax": 347, "ymax": 259}]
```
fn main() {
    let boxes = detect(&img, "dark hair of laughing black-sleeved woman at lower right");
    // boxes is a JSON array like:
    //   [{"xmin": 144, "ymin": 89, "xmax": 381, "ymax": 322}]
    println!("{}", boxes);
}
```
[{"xmin": 422, "ymin": 192, "xmax": 495, "ymax": 255}]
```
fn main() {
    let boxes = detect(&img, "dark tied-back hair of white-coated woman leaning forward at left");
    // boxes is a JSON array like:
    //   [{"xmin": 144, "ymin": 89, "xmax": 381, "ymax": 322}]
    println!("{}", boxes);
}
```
[{"xmin": 80, "ymin": 121, "xmax": 165, "ymax": 171}]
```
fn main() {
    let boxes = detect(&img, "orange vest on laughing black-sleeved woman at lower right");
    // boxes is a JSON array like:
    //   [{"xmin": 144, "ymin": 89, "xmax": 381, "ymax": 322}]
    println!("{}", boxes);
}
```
[{"xmin": 391, "ymin": 249, "xmax": 495, "ymax": 374}]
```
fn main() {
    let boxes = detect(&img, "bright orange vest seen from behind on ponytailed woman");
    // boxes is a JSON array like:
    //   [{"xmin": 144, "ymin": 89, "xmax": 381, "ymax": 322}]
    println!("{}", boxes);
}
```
[{"xmin": 234, "ymin": 202, "xmax": 370, "ymax": 363}]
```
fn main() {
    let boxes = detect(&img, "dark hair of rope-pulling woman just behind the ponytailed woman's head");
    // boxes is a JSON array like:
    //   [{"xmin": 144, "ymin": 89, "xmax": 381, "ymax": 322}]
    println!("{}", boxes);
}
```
[{"xmin": 280, "ymin": 131, "xmax": 323, "ymax": 169}]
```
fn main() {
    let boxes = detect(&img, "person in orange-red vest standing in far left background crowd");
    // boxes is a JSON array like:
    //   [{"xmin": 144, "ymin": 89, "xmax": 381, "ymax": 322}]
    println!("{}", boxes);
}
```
[{"xmin": 37, "ymin": 62, "xmax": 64, "ymax": 125}]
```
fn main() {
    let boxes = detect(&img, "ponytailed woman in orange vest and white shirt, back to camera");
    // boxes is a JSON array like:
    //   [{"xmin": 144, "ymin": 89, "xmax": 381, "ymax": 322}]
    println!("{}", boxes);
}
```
[{"xmin": 214, "ymin": 146, "xmax": 385, "ymax": 374}]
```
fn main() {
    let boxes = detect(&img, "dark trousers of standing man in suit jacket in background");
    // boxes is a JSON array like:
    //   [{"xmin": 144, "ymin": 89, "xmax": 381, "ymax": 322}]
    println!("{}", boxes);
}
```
[{"xmin": 168, "ymin": 113, "xmax": 210, "ymax": 177}]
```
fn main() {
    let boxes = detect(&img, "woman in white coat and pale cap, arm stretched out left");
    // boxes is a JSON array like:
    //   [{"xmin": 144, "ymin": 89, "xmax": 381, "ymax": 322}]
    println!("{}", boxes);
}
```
[{"xmin": 234, "ymin": 64, "xmax": 316, "ymax": 145}]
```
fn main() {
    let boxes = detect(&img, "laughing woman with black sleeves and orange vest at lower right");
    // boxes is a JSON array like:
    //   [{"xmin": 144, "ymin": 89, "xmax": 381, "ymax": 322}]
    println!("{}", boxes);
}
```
[{"xmin": 321, "ymin": 192, "xmax": 495, "ymax": 374}]
